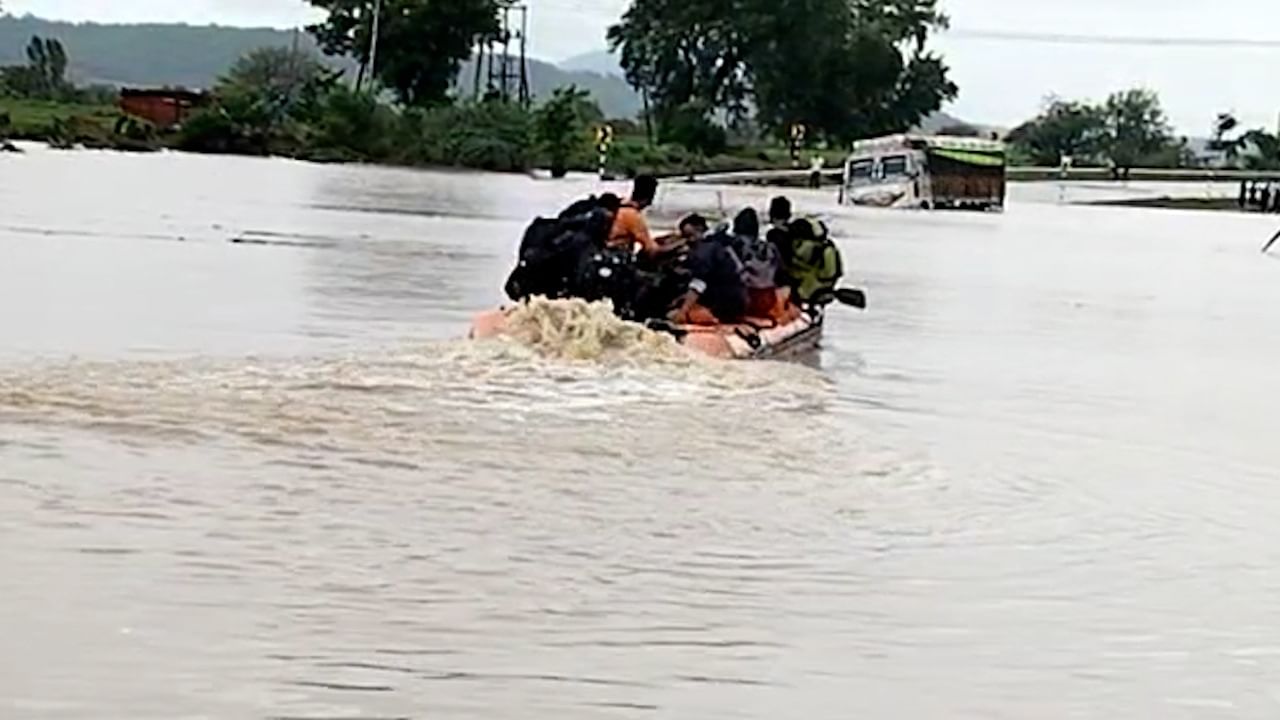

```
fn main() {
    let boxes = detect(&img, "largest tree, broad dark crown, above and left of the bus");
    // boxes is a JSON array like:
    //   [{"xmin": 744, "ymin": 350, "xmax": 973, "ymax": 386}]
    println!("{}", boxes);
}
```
[{"xmin": 609, "ymin": 0, "xmax": 956, "ymax": 147}]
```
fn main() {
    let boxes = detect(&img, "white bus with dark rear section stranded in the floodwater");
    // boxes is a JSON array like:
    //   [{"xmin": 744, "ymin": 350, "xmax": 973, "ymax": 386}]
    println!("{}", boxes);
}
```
[{"xmin": 841, "ymin": 135, "xmax": 1005, "ymax": 211}]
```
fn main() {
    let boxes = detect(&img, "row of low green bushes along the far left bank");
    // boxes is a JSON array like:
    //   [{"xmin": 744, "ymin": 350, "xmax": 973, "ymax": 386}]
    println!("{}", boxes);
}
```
[{"xmin": 179, "ymin": 47, "xmax": 759, "ymax": 174}]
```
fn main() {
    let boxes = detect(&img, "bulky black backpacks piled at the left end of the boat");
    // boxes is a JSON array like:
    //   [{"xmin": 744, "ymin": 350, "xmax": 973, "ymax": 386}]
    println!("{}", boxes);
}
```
[{"xmin": 506, "ymin": 197, "xmax": 613, "ymax": 301}]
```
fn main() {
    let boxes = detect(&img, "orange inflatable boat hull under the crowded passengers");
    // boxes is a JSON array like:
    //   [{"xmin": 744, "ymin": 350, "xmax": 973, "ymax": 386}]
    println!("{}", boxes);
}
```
[{"xmin": 470, "ymin": 307, "xmax": 823, "ymax": 360}]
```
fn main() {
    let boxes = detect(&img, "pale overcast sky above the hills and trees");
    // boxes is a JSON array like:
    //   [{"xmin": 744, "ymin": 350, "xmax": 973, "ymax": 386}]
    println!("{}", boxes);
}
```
[{"xmin": 10, "ymin": 0, "xmax": 1280, "ymax": 135}]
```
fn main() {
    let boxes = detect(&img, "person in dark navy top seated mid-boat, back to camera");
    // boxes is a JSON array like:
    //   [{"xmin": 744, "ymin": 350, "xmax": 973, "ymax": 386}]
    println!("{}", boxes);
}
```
[{"xmin": 671, "ymin": 215, "xmax": 748, "ymax": 325}]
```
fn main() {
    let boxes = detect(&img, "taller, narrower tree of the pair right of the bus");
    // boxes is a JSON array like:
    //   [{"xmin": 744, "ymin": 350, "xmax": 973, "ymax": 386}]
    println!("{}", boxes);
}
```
[{"xmin": 1102, "ymin": 90, "xmax": 1176, "ymax": 178}]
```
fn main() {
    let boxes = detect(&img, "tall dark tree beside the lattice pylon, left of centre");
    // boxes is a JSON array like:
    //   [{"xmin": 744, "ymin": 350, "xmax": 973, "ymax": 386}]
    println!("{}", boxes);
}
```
[{"xmin": 307, "ymin": 0, "xmax": 502, "ymax": 105}]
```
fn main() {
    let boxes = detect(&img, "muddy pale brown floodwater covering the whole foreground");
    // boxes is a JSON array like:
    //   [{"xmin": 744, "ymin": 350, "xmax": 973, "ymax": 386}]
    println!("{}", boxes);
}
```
[{"xmin": 0, "ymin": 146, "xmax": 1280, "ymax": 720}]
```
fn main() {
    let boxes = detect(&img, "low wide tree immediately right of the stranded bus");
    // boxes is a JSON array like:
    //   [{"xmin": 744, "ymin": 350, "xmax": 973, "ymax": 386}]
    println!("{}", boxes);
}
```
[{"xmin": 1009, "ymin": 100, "xmax": 1107, "ymax": 165}]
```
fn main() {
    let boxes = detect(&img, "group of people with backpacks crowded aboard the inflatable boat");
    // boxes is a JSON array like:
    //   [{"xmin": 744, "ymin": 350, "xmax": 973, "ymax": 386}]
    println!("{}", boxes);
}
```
[{"xmin": 507, "ymin": 176, "xmax": 844, "ymax": 325}]
